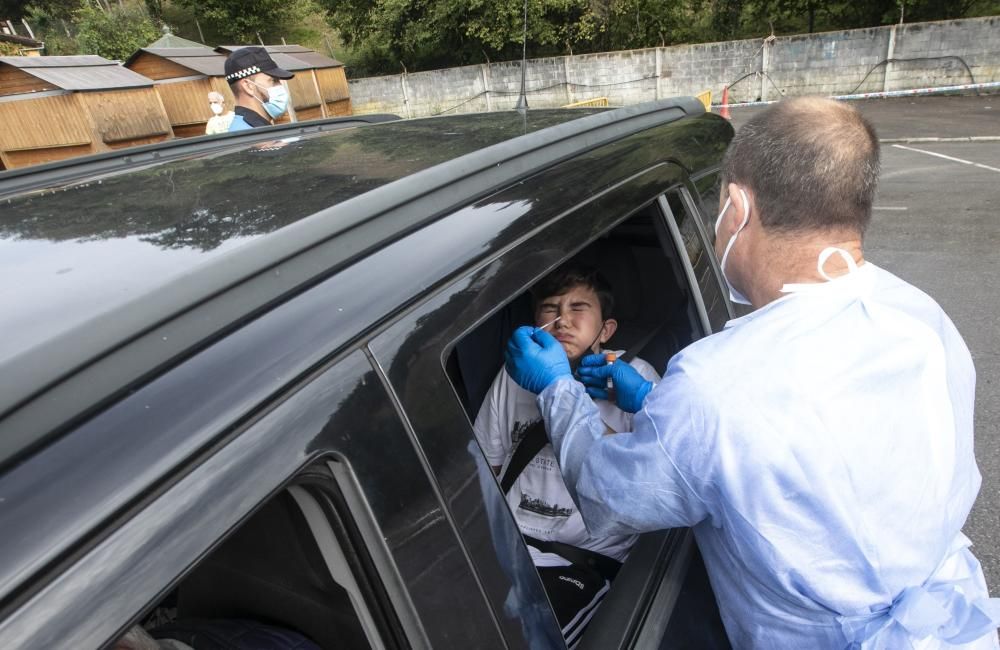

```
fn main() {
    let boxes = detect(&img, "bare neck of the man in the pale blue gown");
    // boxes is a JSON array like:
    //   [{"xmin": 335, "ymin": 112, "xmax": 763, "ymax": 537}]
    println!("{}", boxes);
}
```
[{"xmin": 749, "ymin": 230, "xmax": 864, "ymax": 307}]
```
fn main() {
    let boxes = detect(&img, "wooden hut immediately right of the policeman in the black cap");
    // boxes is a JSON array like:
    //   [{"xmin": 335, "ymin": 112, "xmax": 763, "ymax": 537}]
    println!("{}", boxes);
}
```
[{"xmin": 215, "ymin": 45, "xmax": 352, "ymax": 122}]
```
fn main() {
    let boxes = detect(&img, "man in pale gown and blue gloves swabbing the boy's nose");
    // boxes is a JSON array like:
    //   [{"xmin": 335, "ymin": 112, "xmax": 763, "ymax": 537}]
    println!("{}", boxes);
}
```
[{"xmin": 507, "ymin": 99, "xmax": 1000, "ymax": 650}]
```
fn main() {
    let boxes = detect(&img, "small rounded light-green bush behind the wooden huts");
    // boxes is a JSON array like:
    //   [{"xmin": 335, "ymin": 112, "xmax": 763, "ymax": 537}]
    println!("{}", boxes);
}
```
[{"xmin": 75, "ymin": 3, "xmax": 160, "ymax": 60}]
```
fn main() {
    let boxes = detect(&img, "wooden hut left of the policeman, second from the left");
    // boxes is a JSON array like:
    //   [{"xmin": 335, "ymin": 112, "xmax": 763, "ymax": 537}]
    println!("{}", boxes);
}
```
[{"xmin": 125, "ymin": 45, "xmax": 234, "ymax": 138}]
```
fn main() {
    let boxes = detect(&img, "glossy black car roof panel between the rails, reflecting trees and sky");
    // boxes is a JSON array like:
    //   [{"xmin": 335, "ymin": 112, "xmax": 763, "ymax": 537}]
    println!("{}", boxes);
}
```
[{"xmin": 0, "ymin": 110, "xmax": 600, "ymax": 363}]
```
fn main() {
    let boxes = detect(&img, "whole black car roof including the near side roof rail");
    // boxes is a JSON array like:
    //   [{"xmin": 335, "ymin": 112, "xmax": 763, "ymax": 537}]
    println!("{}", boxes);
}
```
[{"xmin": 0, "ymin": 98, "xmax": 731, "ymax": 463}]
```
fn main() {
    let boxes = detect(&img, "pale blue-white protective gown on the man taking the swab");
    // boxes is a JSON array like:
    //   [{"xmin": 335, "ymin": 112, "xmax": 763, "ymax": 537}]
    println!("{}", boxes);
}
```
[{"xmin": 538, "ymin": 263, "xmax": 1000, "ymax": 650}]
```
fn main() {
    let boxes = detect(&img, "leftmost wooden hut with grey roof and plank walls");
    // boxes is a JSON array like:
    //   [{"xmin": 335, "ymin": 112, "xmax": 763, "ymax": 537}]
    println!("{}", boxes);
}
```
[{"xmin": 0, "ymin": 56, "xmax": 170, "ymax": 169}]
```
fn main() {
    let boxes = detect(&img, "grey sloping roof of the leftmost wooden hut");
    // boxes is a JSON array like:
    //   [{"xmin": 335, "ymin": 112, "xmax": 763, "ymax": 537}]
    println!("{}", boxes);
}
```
[{"xmin": 0, "ymin": 55, "xmax": 153, "ymax": 90}]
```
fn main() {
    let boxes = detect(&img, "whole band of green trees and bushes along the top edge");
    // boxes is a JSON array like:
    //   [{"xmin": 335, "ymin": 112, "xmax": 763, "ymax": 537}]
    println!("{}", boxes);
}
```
[{"xmin": 0, "ymin": 0, "xmax": 1000, "ymax": 76}]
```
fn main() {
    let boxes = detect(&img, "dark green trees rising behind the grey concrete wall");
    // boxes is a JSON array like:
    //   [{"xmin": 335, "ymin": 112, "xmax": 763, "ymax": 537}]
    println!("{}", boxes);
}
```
[{"xmin": 316, "ymin": 0, "xmax": 1000, "ymax": 76}]
